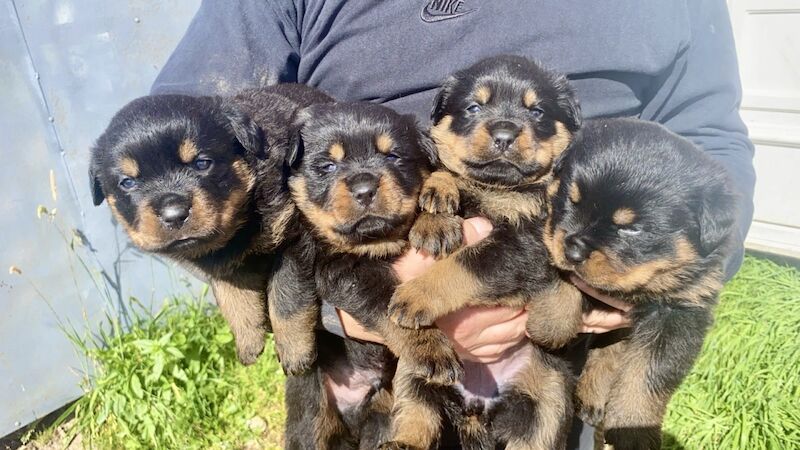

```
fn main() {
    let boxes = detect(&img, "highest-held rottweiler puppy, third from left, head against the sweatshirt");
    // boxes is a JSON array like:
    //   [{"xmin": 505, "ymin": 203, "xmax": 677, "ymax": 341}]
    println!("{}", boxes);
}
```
[{"xmin": 389, "ymin": 56, "xmax": 581, "ymax": 449}]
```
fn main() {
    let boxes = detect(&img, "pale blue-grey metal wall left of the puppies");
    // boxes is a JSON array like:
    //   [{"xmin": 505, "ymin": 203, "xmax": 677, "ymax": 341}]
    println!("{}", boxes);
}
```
[{"xmin": 0, "ymin": 0, "xmax": 199, "ymax": 436}]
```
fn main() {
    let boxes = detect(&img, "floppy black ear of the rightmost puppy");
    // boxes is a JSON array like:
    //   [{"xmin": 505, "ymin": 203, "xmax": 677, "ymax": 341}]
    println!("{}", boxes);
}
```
[{"xmin": 696, "ymin": 180, "xmax": 738, "ymax": 256}]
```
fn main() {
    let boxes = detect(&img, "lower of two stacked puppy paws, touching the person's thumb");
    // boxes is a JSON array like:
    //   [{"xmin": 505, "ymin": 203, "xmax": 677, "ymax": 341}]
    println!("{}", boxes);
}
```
[{"xmin": 408, "ymin": 212, "xmax": 464, "ymax": 258}]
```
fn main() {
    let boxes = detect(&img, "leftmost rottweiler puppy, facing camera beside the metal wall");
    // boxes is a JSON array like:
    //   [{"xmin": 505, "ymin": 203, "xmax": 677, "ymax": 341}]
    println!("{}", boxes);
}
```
[{"xmin": 89, "ymin": 85, "xmax": 332, "ymax": 373}]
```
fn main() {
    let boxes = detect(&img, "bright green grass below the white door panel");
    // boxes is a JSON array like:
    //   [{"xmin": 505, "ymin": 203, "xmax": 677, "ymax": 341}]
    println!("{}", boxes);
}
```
[{"xmin": 665, "ymin": 257, "xmax": 800, "ymax": 450}]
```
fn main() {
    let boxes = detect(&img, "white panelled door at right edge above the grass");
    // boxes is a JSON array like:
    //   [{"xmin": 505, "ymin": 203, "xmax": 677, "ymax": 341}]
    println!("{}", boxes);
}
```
[{"xmin": 728, "ymin": 0, "xmax": 800, "ymax": 257}]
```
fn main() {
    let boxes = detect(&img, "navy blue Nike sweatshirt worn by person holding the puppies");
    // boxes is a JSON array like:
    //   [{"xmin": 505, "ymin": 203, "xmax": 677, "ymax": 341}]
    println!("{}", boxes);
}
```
[{"xmin": 152, "ymin": 0, "xmax": 755, "ymax": 276}]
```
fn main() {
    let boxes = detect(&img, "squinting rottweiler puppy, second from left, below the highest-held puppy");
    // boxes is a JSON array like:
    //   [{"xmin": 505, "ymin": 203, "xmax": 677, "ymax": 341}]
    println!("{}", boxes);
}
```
[{"xmin": 289, "ymin": 103, "xmax": 462, "ymax": 448}]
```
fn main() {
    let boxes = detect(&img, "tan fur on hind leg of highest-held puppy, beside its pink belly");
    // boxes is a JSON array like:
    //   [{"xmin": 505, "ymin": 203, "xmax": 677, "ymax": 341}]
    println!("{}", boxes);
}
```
[{"xmin": 506, "ymin": 346, "xmax": 572, "ymax": 450}]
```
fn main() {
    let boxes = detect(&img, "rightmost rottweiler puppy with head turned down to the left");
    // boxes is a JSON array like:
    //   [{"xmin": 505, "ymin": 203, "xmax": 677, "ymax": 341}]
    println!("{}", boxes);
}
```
[{"xmin": 545, "ymin": 119, "xmax": 736, "ymax": 450}]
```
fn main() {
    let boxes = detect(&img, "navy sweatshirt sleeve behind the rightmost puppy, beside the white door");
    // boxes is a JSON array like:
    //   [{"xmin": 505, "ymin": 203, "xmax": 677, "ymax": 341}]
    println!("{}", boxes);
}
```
[{"xmin": 641, "ymin": 0, "xmax": 756, "ymax": 279}]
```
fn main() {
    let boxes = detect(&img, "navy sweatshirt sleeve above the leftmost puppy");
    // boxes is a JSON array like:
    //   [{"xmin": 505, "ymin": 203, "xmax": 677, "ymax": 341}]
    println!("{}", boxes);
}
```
[{"xmin": 151, "ymin": 0, "xmax": 300, "ymax": 95}]
